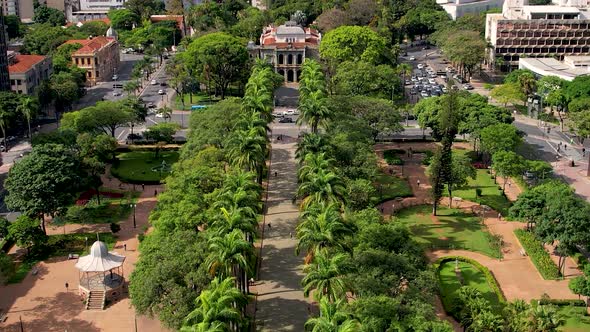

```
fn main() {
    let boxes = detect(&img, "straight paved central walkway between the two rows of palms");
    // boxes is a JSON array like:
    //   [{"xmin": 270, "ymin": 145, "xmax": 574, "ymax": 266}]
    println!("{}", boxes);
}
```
[{"xmin": 253, "ymin": 126, "xmax": 309, "ymax": 332}]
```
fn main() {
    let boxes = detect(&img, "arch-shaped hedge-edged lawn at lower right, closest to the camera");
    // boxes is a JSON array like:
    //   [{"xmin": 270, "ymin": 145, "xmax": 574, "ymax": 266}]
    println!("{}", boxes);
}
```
[{"xmin": 439, "ymin": 262, "xmax": 503, "ymax": 313}]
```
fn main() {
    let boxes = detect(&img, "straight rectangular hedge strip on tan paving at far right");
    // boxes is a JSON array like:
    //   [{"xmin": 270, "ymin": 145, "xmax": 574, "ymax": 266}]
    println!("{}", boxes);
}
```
[{"xmin": 514, "ymin": 229, "xmax": 561, "ymax": 280}]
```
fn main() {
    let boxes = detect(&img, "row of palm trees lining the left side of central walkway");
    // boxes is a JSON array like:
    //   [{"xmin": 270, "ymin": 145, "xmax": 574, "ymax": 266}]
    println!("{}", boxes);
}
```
[{"xmin": 181, "ymin": 62, "xmax": 275, "ymax": 331}]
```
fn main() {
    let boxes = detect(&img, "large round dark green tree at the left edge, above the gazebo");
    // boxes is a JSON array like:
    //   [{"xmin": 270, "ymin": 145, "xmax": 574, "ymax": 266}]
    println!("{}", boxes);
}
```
[{"xmin": 4, "ymin": 144, "xmax": 81, "ymax": 230}]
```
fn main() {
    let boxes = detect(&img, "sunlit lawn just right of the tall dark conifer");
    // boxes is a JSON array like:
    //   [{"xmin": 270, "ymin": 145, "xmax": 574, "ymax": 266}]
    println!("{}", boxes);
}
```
[{"xmin": 445, "ymin": 169, "xmax": 511, "ymax": 216}]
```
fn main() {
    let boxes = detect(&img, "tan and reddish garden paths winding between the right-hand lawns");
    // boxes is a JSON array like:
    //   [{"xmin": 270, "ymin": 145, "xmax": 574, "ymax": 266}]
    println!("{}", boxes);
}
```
[{"xmin": 376, "ymin": 143, "xmax": 580, "ymax": 300}]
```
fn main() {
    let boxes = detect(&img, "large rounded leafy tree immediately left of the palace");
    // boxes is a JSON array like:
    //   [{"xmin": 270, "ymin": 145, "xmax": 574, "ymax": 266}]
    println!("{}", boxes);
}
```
[{"xmin": 183, "ymin": 32, "xmax": 248, "ymax": 99}]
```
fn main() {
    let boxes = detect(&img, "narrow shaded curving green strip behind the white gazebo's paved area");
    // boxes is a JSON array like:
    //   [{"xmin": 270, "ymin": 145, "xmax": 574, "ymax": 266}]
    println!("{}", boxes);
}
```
[{"xmin": 7, "ymin": 233, "xmax": 117, "ymax": 284}]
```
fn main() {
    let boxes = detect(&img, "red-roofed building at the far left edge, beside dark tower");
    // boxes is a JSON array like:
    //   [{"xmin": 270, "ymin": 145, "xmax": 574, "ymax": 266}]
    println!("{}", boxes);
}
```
[{"xmin": 8, "ymin": 51, "xmax": 53, "ymax": 95}]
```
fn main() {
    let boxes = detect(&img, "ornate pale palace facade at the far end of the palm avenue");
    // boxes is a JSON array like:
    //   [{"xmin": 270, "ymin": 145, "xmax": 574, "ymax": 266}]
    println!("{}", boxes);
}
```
[{"xmin": 248, "ymin": 21, "xmax": 322, "ymax": 82}]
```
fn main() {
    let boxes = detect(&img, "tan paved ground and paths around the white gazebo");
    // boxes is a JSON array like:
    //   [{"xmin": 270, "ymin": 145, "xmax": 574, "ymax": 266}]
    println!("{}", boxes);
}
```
[{"xmin": 0, "ymin": 171, "xmax": 167, "ymax": 332}]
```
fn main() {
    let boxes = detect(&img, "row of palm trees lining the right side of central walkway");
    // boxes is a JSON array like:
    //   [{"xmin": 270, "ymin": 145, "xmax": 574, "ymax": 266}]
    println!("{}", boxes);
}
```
[{"xmin": 295, "ymin": 60, "xmax": 360, "ymax": 332}]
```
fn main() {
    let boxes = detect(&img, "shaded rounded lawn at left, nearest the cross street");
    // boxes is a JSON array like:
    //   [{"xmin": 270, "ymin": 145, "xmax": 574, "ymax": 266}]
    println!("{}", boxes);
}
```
[{"xmin": 111, "ymin": 151, "xmax": 179, "ymax": 184}]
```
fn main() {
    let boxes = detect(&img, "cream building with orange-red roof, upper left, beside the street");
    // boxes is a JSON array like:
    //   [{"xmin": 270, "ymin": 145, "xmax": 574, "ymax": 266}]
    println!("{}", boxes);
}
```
[{"xmin": 66, "ymin": 36, "xmax": 120, "ymax": 85}]
